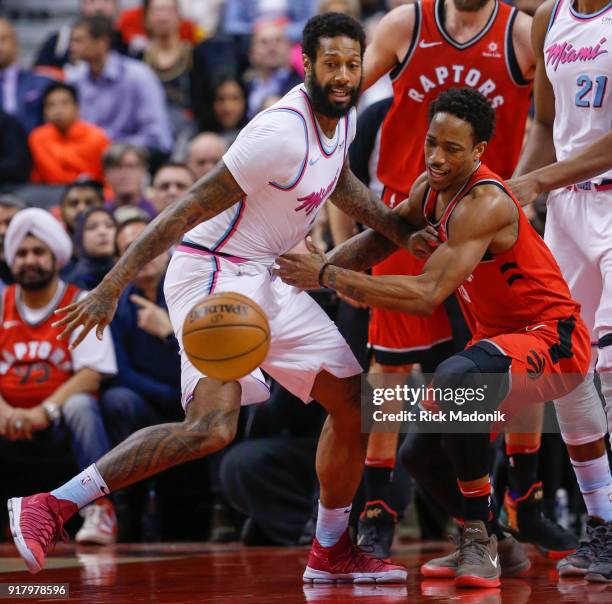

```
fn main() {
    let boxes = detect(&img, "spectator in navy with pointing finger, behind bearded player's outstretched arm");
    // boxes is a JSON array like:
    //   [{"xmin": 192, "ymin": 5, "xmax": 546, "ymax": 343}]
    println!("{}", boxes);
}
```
[{"xmin": 101, "ymin": 219, "xmax": 183, "ymax": 442}]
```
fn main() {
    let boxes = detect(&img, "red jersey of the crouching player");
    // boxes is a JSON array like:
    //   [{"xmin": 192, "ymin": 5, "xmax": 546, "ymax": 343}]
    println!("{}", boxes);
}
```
[{"xmin": 423, "ymin": 164, "xmax": 580, "ymax": 339}]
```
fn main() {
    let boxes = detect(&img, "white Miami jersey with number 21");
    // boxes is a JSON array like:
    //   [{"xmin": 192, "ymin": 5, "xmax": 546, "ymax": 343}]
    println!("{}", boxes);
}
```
[{"xmin": 544, "ymin": 0, "xmax": 612, "ymax": 182}]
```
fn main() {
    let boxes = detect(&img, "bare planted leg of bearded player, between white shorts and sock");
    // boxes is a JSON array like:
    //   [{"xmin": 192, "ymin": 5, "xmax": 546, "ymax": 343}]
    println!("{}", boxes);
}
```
[{"xmin": 312, "ymin": 371, "xmax": 368, "ymax": 508}]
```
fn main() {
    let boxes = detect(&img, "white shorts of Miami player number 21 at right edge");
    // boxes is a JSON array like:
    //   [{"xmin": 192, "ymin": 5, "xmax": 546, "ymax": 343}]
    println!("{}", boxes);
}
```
[{"xmin": 544, "ymin": 189, "xmax": 612, "ymax": 356}]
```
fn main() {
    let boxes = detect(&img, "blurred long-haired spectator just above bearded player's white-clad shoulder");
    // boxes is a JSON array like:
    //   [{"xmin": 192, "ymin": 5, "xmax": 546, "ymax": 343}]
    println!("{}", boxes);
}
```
[{"xmin": 206, "ymin": 73, "xmax": 248, "ymax": 146}]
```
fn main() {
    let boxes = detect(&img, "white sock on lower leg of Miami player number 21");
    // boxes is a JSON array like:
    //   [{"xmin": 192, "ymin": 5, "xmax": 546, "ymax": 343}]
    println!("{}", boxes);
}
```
[{"xmin": 571, "ymin": 453, "xmax": 612, "ymax": 522}]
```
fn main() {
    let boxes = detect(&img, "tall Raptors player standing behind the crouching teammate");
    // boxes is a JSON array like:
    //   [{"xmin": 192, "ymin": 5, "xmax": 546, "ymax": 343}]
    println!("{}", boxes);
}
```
[{"xmin": 358, "ymin": 0, "xmax": 577, "ymax": 557}]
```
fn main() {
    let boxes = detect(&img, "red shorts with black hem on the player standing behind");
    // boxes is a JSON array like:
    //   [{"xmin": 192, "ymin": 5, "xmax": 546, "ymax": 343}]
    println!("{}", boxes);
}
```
[{"xmin": 368, "ymin": 187, "xmax": 453, "ymax": 365}]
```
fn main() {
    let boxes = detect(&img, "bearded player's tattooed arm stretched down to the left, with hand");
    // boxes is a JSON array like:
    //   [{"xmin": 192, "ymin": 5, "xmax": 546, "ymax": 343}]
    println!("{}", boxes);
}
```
[{"xmin": 54, "ymin": 162, "xmax": 244, "ymax": 348}]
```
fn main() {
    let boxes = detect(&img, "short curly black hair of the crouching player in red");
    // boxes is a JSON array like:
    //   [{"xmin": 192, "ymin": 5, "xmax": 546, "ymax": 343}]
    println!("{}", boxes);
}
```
[{"xmin": 429, "ymin": 87, "xmax": 495, "ymax": 143}]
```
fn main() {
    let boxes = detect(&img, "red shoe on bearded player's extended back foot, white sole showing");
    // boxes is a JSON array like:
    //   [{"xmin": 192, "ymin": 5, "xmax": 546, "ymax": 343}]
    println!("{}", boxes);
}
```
[{"xmin": 8, "ymin": 493, "xmax": 78, "ymax": 574}]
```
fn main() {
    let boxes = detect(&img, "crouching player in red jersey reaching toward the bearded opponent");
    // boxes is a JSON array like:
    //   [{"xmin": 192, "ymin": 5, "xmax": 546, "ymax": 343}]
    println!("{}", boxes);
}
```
[{"xmin": 278, "ymin": 88, "xmax": 590, "ymax": 587}]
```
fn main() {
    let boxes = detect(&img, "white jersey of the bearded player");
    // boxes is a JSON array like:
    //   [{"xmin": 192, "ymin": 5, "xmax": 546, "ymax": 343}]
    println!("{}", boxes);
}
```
[{"xmin": 179, "ymin": 85, "xmax": 356, "ymax": 265}]
